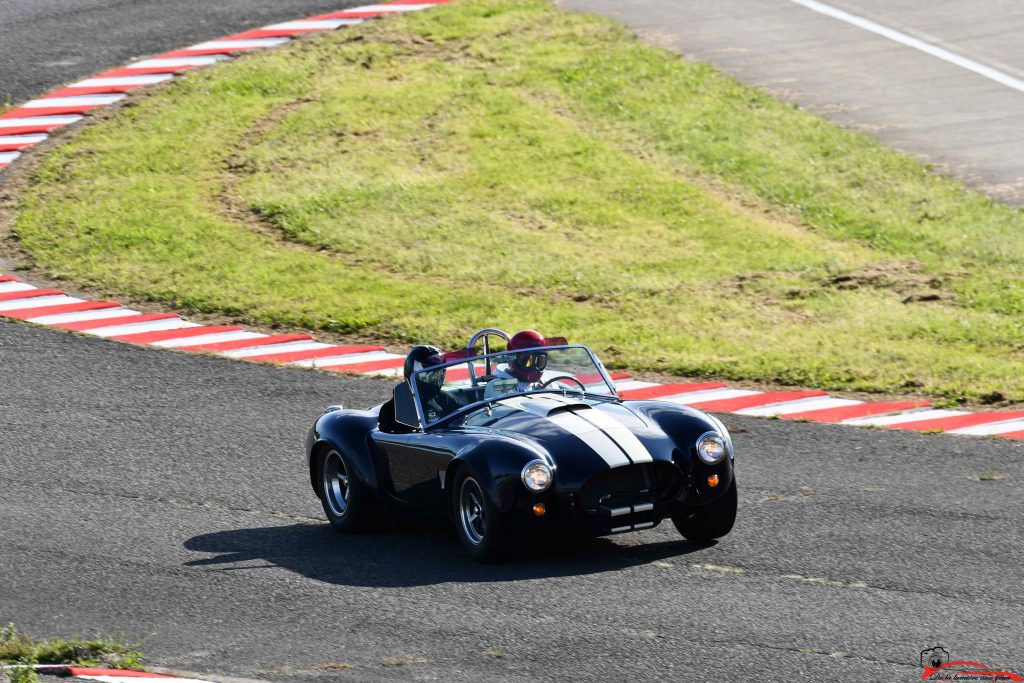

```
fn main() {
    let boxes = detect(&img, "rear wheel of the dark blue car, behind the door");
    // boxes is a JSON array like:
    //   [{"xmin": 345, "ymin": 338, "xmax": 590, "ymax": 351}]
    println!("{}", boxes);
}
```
[{"xmin": 319, "ymin": 449, "xmax": 390, "ymax": 533}]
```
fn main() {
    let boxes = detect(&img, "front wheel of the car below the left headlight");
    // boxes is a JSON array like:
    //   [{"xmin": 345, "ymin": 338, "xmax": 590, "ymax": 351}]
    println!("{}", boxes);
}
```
[{"xmin": 451, "ymin": 469, "xmax": 514, "ymax": 562}]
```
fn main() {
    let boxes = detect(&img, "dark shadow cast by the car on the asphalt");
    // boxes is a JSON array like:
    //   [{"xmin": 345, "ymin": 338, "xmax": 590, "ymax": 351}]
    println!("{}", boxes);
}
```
[{"xmin": 184, "ymin": 523, "xmax": 714, "ymax": 588}]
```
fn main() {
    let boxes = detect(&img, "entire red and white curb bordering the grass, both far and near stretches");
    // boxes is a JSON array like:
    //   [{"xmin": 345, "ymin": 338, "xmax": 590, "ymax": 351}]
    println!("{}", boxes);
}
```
[{"xmin": 0, "ymin": 0, "xmax": 1024, "ymax": 439}]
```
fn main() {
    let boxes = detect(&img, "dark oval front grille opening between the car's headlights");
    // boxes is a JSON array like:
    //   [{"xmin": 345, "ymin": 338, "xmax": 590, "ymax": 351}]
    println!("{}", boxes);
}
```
[{"xmin": 580, "ymin": 462, "xmax": 680, "ymax": 513}]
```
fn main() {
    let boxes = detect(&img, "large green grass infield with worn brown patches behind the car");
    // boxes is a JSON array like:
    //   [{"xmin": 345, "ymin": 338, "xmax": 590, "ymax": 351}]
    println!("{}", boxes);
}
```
[{"xmin": 14, "ymin": 0, "xmax": 1024, "ymax": 401}]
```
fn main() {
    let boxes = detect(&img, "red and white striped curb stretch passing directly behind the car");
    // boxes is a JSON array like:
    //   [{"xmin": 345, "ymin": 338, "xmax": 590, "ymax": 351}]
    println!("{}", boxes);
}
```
[{"xmin": 0, "ymin": 273, "xmax": 1024, "ymax": 439}]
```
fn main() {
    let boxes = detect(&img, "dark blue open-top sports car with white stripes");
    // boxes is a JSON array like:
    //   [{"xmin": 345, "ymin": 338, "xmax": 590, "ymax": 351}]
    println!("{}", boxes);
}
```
[{"xmin": 306, "ymin": 330, "xmax": 736, "ymax": 561}]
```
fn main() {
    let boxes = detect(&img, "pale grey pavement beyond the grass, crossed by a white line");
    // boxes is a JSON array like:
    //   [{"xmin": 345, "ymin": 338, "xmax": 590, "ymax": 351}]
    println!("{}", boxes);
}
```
[{"xmin": 559, "ymin": 0, "xmax": 1024, "ymax": 206}]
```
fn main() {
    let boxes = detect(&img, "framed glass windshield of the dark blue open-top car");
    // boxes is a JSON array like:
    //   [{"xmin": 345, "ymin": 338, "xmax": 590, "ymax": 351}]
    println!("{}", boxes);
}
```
[{"xmin": 413, "ymin": 346, "xmax": 615, "ymax": 425}]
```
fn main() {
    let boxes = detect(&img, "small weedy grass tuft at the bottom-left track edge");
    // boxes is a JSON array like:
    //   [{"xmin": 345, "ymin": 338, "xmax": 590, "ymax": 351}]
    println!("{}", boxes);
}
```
[{"xmin": 0, "ymin": 624, "xmax": 142, "ymax": 669}]
